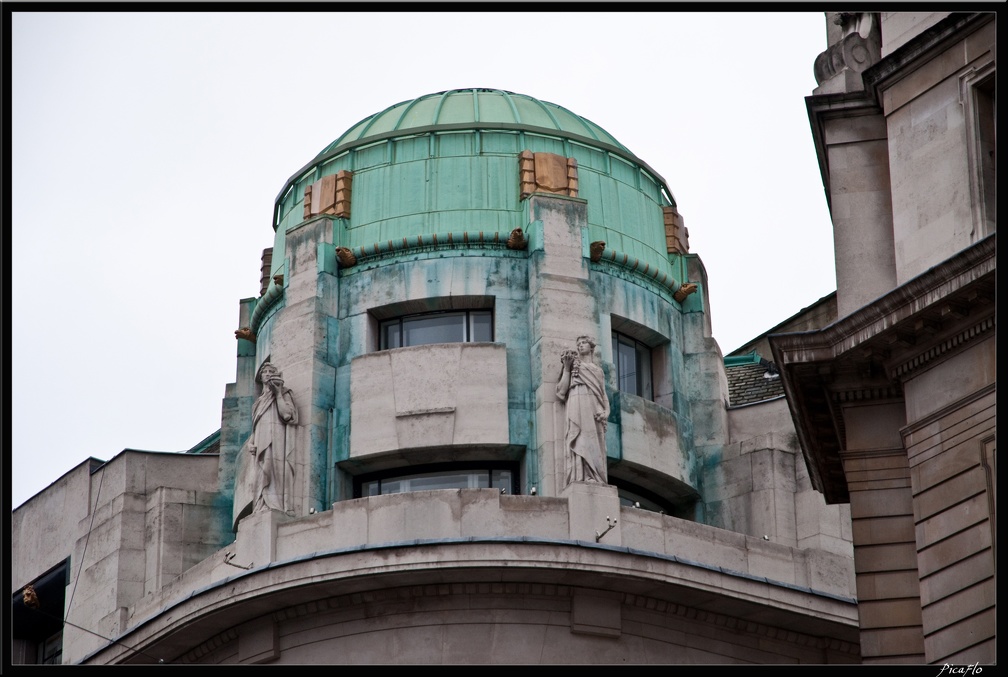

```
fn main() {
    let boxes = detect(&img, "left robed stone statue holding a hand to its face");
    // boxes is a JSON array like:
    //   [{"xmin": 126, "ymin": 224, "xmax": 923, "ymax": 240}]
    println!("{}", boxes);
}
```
[{"xmin": 242, "ymin": 362, "xmax": 297, "ymax": 514}]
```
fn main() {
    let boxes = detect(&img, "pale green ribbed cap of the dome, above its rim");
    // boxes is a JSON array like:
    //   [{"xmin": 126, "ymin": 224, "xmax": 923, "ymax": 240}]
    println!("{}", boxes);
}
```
[{"xmin": 316, "ymin": 89, "xmax": 633, "ymax": 160}]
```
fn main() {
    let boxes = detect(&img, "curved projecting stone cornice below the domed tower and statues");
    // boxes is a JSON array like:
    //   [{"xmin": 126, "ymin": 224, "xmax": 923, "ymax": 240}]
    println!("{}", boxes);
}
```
[{"xmin": 88, "ymin": 535, "xmax": 857, "ymax": 664}]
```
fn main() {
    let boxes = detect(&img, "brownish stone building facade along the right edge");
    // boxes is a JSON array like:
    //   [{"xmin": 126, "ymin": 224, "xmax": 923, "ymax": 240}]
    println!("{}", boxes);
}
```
[{"xmin": 769, "ymin": 12, "xmax": 997, "ymax": 664}]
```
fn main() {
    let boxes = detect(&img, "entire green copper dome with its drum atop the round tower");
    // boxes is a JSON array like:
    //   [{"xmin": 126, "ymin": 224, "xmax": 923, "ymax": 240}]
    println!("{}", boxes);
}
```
[{"xmin": 273, "ymin": 89, "xmax": 679, "ymax": 286}]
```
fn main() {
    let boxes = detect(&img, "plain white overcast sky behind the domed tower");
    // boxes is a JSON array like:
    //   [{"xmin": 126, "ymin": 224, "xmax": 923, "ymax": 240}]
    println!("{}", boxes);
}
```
[{"xmin": 11, "ymin": 10, "xmax": 836, "ymax": 507}]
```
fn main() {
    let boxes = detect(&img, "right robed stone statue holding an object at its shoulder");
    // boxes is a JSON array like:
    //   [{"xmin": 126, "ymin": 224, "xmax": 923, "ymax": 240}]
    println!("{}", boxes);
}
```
[{"xmin": 556, "ymin": 336, "xmax": 609, "ymax": 486}]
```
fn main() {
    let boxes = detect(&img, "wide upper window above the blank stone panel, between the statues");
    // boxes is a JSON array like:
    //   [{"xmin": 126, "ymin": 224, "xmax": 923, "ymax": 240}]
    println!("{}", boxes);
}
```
[{"xmin": 378, "ymin": 310, "xmax": 494, "ymax": 351}]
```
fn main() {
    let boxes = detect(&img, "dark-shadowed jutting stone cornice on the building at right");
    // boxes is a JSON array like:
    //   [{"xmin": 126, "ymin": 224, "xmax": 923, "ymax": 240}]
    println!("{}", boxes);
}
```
[{"xmin": 768, "ymin": 234, "xmax": 997, "ymax": 503}]
